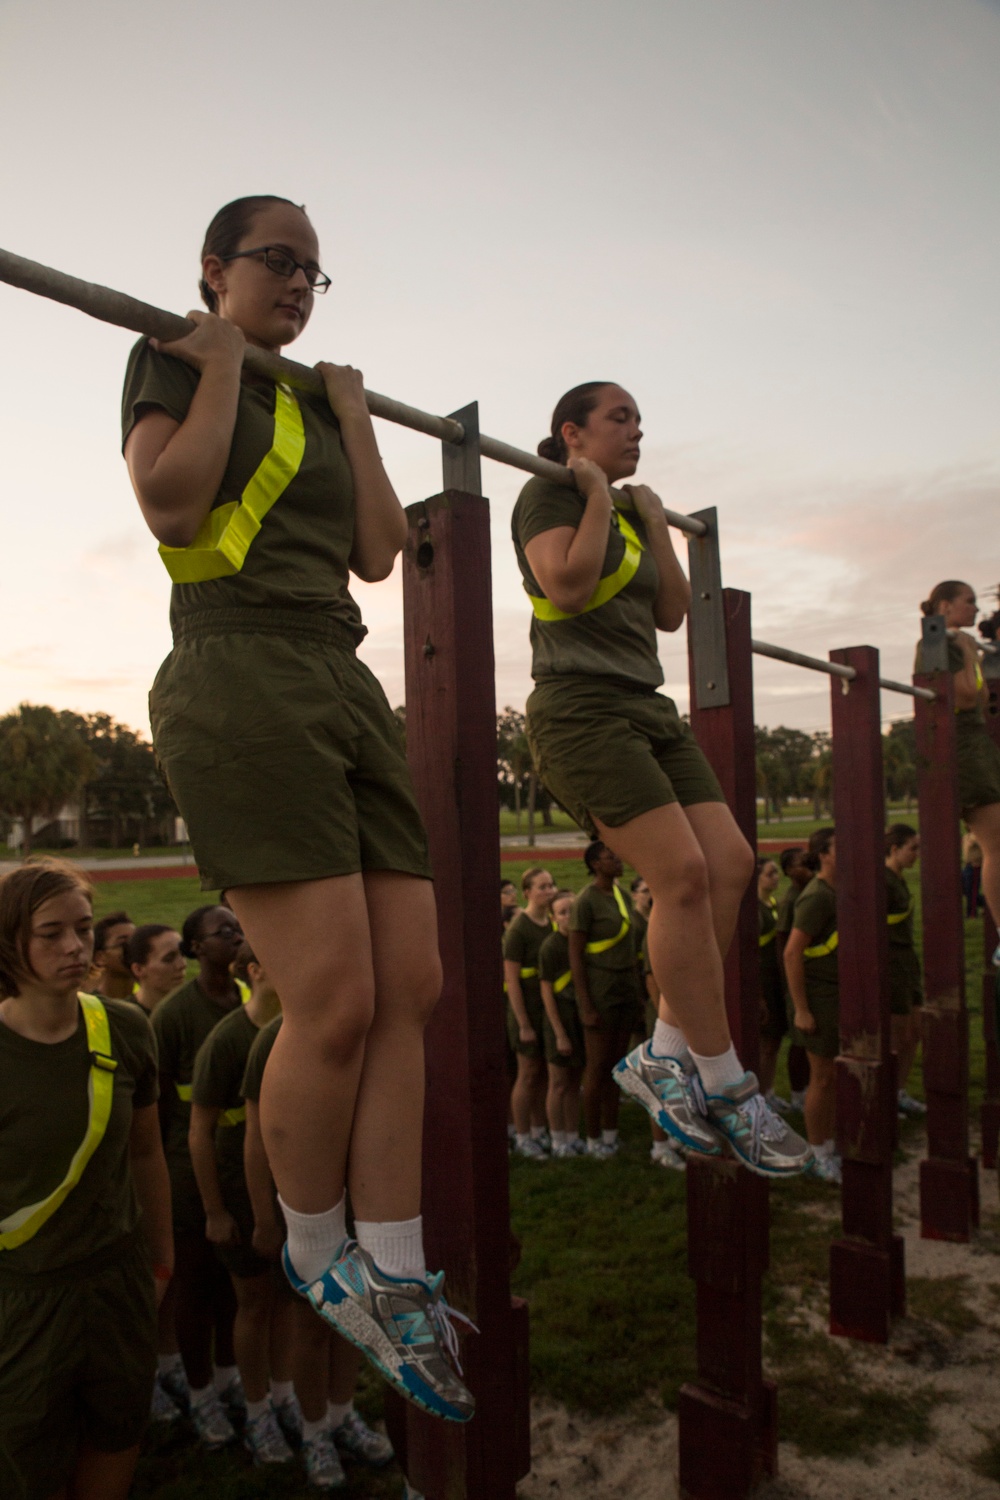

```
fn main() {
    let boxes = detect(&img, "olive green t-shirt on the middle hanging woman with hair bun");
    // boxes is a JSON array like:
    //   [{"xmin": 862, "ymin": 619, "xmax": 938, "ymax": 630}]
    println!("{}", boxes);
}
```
[{"xmin": 511, "ymin": 477, "xmax": 663, "ymax": 687}]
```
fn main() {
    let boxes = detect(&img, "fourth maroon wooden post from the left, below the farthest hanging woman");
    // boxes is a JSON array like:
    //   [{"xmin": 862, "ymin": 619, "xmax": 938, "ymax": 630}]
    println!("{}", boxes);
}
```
[{"xmin": 913, "ymin": 671, "xmax": 979, "ymax": 1241}]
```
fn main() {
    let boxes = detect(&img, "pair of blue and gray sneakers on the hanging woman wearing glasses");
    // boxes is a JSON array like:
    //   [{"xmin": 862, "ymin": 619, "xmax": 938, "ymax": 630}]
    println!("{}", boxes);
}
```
[{"xmin": 282, "ymin": 1241, "xmax": 475, "ymax": 1422}]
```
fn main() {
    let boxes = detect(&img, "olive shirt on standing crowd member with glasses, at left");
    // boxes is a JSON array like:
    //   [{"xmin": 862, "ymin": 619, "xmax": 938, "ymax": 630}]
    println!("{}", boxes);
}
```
[{"xmin": 153, "ymin": 977, "xmax": 238, "ymax": 1233}]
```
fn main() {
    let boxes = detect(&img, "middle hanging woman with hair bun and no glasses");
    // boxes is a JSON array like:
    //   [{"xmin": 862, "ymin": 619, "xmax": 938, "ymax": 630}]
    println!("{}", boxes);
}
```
[{"xmin": 513, "ymin": 381, "xmax": 810, "ymax": 1176}]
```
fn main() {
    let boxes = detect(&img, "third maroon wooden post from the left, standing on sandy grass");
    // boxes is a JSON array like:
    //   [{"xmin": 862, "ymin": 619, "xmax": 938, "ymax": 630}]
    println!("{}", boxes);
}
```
[{"xmin": 831, "ymin": 647, "xmax": 906, "ymax": 1344}]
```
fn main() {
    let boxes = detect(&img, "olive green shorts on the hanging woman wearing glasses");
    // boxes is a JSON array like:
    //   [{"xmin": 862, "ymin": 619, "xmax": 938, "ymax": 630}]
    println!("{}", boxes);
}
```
[{"xmin": 150, "ymin": 609, "xmax": 430, "ymax": 890}]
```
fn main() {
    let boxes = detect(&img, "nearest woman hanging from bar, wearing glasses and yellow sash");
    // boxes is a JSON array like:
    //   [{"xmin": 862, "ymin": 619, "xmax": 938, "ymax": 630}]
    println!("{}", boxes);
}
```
[{"xmin": 123, "ymin": 195, "xmax": 472, "ymax": 1421}]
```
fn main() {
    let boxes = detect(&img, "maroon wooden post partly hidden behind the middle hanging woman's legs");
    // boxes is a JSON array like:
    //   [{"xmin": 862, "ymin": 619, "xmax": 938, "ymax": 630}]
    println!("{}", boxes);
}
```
[{"xmin": 678, "ymin": 582, "xmax": 778, "ymax": 1500}]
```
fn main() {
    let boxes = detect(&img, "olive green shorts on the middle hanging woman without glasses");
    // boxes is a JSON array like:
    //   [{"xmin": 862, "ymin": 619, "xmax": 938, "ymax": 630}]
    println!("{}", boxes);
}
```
[{"xmin": 526, "ymin": 677, "xmax": 726, "ymax": 836}]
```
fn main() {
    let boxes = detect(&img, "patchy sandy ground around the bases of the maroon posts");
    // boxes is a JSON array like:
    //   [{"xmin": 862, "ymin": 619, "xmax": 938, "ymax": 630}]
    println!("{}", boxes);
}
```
[{"xmin": 517, "ymin": 1152, "xmax": 1000, "ymax": 1500}]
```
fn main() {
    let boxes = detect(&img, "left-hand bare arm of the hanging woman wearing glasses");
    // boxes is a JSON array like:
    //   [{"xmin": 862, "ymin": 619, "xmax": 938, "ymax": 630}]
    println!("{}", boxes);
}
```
[{"xmin": 124, "ymin": 312, "xmax": 244, "ymax": 548}]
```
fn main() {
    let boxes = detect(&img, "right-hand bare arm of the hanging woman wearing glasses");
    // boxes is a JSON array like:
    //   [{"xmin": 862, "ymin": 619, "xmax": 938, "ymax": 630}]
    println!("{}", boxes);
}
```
[{"xmin": 316, "ymin": 363, "xmax": 408, "ymax": 584}]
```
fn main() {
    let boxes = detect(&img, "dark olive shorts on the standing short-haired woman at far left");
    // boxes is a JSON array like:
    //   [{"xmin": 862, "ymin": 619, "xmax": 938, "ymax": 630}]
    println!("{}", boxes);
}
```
[{"xmin": 0, "ymin": 1238, "xmax": 156, "ymax": 1500}]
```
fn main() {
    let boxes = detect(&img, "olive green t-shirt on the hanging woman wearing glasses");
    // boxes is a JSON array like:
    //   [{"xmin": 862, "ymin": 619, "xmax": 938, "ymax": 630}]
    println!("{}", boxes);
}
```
[{"xmin": 121, "ymin": 339, "xmax": 366, "ymax": 644}]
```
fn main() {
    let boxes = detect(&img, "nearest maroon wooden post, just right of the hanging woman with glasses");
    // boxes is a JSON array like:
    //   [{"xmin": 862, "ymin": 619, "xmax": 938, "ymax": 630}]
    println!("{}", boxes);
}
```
[{"xmin": 394, "ymin": 489, "xmax": 531, "ymax": 1500}]
